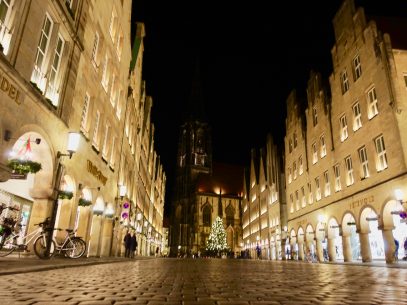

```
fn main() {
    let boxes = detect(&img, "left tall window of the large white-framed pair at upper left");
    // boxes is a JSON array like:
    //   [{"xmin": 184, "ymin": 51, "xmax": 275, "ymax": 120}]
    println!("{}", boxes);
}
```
[{"xmin": 31, "ymin": 14, "xmax": 54, "ymax": 92}]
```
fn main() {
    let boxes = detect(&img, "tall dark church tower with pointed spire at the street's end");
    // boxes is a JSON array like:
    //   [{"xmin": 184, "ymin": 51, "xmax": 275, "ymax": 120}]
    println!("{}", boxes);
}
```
[{"xmin": 170, "ymin": 60, "xmax": 212, "ymax": 256}]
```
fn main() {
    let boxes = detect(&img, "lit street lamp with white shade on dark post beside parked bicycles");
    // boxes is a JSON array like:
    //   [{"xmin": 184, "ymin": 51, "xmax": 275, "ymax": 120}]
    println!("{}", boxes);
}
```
[{"xmin": 44, "ymin": 132, "xmax": 80, "ymax": 258}]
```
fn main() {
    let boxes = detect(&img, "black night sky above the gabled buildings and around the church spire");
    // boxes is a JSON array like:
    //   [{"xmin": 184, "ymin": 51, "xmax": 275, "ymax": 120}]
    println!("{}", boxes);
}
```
[{"xmin": 132, "ymin": 0, "xmax": 407, "ymax": 216}]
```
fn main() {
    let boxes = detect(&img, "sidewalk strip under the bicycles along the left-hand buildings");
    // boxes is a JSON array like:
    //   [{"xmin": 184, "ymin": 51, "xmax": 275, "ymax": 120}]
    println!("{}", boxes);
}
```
[{"xmin": 0, "ymin": 254, "xmax": 154, "ymax": 276}]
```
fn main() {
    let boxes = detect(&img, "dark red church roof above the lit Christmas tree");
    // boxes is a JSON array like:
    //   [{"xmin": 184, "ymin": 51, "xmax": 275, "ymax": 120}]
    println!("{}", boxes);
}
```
[{"xmin": 197, "ymin": 162, "xmax": 244, "ymax": 196}]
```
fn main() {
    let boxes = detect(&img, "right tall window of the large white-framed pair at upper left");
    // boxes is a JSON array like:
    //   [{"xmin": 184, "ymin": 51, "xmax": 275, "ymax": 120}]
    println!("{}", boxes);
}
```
[{"xmin": 45, "ymin": 35, "xmax": 65, "ymax": 106}]
